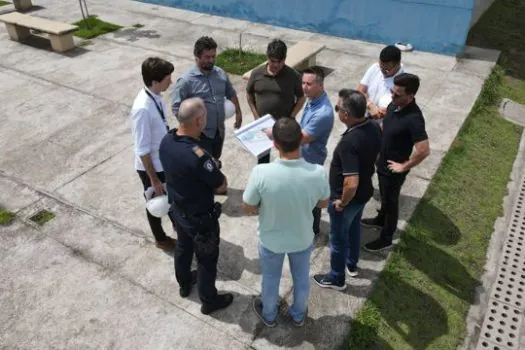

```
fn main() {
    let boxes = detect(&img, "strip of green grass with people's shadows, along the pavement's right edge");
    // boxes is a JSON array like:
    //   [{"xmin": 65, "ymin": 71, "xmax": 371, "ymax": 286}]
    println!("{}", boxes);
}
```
[{"xmin": 347, "ymin": 0, "xmax": 525, "ymax": 350}]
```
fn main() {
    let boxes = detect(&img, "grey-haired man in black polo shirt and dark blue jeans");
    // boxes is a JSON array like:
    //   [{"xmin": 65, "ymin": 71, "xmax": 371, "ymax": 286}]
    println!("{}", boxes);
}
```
[{"xmin": 314, "ymin": 89, "xmax": 381, "ymax": 290}]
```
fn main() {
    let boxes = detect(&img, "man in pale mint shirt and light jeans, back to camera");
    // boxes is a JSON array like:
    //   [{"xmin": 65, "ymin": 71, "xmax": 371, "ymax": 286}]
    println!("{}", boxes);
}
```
[{"xmin": 243, "ymin": 118, "xmax": 330, "ymax": 327}]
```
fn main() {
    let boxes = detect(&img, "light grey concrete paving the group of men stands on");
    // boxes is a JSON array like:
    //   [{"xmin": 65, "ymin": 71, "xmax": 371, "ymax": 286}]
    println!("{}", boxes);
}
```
[{"xmin": 0, "ymin": 0, "xmax": 498, "ymax": 349}]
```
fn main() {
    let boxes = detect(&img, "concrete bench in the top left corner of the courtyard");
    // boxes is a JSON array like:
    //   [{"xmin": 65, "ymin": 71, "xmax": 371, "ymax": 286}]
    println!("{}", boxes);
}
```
[{"xmin": 0, "ymin": 12, "xmax": 78, "ymax": 52}]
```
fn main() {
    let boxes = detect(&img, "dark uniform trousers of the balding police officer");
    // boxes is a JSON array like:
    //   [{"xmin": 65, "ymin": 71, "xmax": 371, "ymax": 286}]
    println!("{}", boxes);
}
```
[{"xmin": 170, "ymin": 212, "xmax": 220, "ymax": 304}]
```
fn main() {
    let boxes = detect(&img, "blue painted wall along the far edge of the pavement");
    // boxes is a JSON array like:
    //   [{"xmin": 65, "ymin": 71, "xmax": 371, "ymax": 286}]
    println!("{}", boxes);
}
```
[{"xmin": 139, "ymin": 0, "xmax": 475, "ymax": 54}]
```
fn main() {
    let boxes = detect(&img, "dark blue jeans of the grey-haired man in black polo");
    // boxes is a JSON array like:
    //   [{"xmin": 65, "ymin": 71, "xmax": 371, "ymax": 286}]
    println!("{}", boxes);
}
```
[{"xmin": 328, "ymin": 201, "xmax": 365, "ymax": 282}]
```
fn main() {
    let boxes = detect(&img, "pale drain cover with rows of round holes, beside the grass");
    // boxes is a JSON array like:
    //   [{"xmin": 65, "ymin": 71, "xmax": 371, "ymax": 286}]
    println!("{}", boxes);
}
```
[{"xmin": 476, "ymin": 177, "xmax": 525, "ymax": 350}]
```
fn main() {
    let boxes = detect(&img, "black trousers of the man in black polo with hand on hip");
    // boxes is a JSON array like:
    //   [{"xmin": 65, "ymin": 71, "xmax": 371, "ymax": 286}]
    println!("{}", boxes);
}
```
[{"xmin": 377, "ymin": 174, "xmax": 406, "ymax": 243}]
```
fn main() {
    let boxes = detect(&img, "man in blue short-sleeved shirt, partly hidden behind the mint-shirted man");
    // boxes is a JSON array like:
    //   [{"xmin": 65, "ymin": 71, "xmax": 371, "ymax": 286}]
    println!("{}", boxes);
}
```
[{"xmin": 301, "ymin": 67, "xmax": 334, "ymax": 234}]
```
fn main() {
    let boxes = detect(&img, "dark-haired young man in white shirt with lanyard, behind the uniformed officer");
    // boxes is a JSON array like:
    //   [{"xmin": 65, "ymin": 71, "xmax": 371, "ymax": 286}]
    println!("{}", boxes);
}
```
[{"xmin": 130, "ymin": 57, "xmax": 175, "ymax": 250}]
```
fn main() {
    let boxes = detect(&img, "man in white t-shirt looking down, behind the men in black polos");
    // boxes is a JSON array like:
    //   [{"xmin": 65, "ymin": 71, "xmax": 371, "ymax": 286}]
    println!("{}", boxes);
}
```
[{"xmin": 357, "ymin": 45, "xmax": 404, "ymax": 119}]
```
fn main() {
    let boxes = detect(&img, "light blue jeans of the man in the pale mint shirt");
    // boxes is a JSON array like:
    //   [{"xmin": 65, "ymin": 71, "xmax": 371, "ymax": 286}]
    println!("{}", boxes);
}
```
[{"xmin": 259, "ymin": 243, "xmax": 312, "ymax": 322}]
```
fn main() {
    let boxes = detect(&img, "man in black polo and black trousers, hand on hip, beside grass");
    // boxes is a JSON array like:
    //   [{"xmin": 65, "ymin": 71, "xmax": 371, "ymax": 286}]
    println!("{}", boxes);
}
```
[{"xmin": 362, "ymin": 73, "xmax": 430, "ymax": 251}]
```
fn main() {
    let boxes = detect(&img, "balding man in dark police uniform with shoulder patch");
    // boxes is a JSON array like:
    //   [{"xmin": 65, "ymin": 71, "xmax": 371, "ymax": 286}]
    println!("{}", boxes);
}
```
[{"xmin": 159, "ymin": 97, "xmax": 233, "ymax": 315}]
